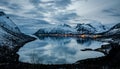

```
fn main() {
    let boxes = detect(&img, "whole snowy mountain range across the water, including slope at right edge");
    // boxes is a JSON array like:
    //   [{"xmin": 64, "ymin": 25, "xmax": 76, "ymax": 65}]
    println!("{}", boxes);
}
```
[{"xmin": 35, "ymin": 22, "xmax": 120, "ymax": 38}]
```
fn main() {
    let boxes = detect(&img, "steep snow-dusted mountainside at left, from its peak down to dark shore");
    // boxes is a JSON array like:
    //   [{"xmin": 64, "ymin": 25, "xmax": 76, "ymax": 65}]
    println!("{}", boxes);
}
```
[{"xmin": 0, "ymin": 12, "xmax": 35, "ymax": 62}]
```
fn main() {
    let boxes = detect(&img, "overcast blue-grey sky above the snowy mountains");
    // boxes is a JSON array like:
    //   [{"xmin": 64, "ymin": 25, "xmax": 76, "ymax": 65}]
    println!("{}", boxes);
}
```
[{"xmin": 0, "ymin": 0, "xmax": 120, "ymax": 24}]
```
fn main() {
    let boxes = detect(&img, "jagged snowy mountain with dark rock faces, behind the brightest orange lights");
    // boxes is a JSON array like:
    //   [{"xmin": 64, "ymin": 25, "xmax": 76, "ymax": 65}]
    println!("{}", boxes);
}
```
[{"xmin": 75, "ymin": 22, "xmax": 107, "ymax": 34}]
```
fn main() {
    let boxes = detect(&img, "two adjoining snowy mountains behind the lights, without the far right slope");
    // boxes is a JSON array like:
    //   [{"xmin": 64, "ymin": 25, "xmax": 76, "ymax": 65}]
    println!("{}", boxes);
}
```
[{"xmin": 35, "ymin": 23, "xmax": 108, "ymax": 34}]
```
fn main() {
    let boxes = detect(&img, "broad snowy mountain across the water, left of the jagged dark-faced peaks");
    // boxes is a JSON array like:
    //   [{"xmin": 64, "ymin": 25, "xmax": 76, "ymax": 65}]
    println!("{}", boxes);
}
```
[{"xmin": 35, "ymin": 24, "xmax": 76, "ymax": 35}]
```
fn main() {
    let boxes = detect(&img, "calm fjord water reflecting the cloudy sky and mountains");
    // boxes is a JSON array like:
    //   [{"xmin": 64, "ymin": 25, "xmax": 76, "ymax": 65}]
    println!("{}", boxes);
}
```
[{"xmin": 18, "ymin": 37, "xmax": 104, "ymax": 64}]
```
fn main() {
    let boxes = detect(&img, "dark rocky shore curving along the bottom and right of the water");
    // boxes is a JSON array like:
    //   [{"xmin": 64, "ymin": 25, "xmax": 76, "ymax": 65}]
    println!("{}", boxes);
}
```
[{"xmin": 0, "ymin": 43, "xmax": 120, "ymax": 69}]
